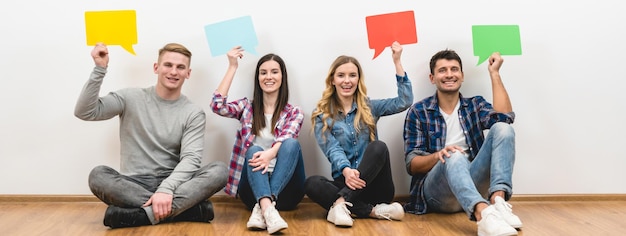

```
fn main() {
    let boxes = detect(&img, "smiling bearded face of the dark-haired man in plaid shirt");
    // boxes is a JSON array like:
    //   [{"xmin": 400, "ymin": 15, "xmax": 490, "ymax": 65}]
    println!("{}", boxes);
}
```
[{"xmin": 429, "ymin": 59, "xmax": 463, "ymax": 93}]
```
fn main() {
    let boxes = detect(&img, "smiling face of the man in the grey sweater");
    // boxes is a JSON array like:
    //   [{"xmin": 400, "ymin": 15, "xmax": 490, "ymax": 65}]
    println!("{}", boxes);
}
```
[{"xmin": 154, "ymin": 52, "xmax": 191, "ymax": 93}]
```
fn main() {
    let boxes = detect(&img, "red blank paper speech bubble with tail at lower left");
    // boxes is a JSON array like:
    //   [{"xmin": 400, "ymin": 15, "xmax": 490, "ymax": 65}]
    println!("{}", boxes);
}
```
[{"xmin": 365, "ymin": 11, "xmax": 417, "ymax": 59}]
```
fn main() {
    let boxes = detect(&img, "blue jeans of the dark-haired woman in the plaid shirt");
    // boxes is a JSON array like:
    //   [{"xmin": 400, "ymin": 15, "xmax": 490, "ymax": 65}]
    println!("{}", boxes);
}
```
[{"xmin": 238, "ymin": 139, "xmax": 306, "ymax": 210}]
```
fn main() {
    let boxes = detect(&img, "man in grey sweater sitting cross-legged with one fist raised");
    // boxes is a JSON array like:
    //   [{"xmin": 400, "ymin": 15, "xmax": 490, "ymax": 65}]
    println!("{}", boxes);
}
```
[{"xmin": 74, "ymin": 43, "xmax": 228, "ymax": 228}]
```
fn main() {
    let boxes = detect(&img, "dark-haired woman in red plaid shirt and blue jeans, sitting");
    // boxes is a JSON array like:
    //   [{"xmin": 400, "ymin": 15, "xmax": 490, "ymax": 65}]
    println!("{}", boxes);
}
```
[{"xmin": 211, "ymin": 46, "xmax": 305, "ymax": 234}]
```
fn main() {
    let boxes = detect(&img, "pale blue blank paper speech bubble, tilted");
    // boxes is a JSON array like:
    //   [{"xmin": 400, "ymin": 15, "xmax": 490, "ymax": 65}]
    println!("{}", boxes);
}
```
[{"xmin": 204, "ymin": 16, "xmax": 259, "ymax": 57}]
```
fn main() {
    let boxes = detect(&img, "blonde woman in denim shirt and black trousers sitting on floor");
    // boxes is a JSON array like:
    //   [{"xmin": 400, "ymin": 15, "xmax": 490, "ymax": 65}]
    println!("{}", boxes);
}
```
[{"xmin": 304, "ymin": 42, "xmax": 413, "ymax": 227}]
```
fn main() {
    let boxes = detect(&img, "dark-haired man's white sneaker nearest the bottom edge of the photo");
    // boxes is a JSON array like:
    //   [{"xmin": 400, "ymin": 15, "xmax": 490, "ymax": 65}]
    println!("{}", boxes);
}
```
[{"xmin": 476, "ymin": 205, "xmax": 517, "ymax": 236}]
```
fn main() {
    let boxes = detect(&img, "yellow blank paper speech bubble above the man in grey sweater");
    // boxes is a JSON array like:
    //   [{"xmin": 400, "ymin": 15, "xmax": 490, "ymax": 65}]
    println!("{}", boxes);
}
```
[{"xmin": 85, "ymin": 10, "xmax": 137, "ymax": 55}]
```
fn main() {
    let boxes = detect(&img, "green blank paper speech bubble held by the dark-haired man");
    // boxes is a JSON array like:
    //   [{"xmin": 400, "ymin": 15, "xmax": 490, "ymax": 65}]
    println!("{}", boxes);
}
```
[{"xmin": 472, "ymin": 25, "xmax": 522, "ymax": 65}]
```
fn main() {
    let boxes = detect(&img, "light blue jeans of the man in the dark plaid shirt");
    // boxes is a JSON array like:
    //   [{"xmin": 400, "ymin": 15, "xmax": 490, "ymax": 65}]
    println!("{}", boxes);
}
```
[{"xmin": 424, "ymin": 123, "xmax": 515, "ymax": 220}]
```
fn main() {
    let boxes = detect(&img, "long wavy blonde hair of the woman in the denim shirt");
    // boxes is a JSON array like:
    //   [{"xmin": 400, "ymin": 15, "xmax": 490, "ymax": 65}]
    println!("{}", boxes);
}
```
[{"xmin": 311, "ymin": 55, "xmax": 376, "ymax": 141}]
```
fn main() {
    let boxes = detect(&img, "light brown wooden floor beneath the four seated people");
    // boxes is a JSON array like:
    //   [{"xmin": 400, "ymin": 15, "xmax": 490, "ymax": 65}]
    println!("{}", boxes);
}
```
[{"xmin": 0, "ymin": 195, "xmax": 626, "ymax": 236}]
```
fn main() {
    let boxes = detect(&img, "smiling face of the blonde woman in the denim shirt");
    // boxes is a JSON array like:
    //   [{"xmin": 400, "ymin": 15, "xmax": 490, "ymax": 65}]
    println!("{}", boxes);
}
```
[{"xmin": 332, "ymin": 62, "xmax": 359, "ymax": 101}]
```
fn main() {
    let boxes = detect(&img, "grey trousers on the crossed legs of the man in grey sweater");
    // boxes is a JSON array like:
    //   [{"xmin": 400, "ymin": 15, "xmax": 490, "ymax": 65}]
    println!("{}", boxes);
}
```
[{"xmin": 89, "ymin": 162, "xmax": 228, "ymax": 224}]
